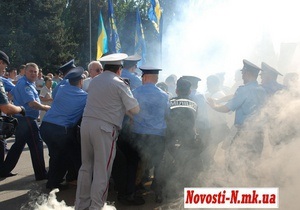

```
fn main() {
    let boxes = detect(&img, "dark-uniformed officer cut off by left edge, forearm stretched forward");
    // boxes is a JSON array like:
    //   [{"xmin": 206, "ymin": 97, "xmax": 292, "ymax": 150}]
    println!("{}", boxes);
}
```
[{"xmin": 0, "ymin": 51, "xmax": 25, "ymax": 177}]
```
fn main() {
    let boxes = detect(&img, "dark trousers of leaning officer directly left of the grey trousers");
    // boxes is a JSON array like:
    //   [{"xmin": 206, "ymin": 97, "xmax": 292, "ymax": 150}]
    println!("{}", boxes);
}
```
[{"xmin": 40, "ymin": 121, "xmax": 80, "ymax": 188}]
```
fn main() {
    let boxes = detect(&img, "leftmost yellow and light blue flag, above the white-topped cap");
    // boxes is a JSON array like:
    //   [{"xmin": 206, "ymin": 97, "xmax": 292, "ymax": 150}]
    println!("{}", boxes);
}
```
[{"xmin": 96, "ymin": 11, "xmax": 108, "ymax": 60}]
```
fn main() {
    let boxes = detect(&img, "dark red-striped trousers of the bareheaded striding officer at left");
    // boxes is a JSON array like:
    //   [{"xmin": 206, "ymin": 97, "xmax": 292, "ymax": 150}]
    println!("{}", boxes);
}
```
[{"xmin": 1, "ymin": 116, "xmax": 47, "ymax": 180}]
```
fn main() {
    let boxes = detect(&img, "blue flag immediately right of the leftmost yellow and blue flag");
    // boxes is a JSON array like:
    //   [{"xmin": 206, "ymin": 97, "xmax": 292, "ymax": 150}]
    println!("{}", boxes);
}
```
[{"xmin": 108, "ymin": 0, "xmax": 121, "ymax": 53}]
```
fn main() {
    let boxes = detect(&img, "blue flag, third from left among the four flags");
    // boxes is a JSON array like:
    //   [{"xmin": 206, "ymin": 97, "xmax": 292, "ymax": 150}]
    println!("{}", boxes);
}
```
[{"xmin": 134, "ymin": 9, "xmax": 147, "ymax": 66}]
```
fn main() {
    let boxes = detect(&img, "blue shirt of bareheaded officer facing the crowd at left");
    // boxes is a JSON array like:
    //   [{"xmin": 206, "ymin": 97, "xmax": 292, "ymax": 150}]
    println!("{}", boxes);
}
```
[{"xmin": 11, "ymin": 77, "xmax": 41, "ymax": 119}]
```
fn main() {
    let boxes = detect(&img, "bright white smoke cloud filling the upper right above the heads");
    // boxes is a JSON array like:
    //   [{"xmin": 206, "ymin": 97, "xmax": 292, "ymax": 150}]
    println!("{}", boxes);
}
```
[{"xmin": 161, "ymin": 0, "xmax": 300, "ymax": 91}]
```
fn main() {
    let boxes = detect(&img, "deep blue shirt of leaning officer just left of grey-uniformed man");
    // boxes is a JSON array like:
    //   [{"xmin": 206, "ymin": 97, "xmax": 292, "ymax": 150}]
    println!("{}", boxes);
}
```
[{"xmin": 43, "ymin": 83, "xmax": 87, "ymax": 127}]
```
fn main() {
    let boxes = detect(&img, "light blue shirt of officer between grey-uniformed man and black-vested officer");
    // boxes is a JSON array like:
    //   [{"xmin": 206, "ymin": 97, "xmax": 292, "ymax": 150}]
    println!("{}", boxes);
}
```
[{"xmin": 132, "ymin": 84, "xmax": 169, "ymax": 136}]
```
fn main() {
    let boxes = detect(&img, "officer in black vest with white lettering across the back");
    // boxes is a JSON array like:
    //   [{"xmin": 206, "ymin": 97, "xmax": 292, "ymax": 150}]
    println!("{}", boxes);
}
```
[{"xmin": 164, "ymin": 78, "xmax": 200, "ymax": 198}]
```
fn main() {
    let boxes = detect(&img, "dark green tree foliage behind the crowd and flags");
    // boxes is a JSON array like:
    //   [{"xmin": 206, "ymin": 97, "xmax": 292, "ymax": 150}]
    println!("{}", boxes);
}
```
[{"xmin": 0, "ymin": 0, "xmax": 176, "ymax": 72}]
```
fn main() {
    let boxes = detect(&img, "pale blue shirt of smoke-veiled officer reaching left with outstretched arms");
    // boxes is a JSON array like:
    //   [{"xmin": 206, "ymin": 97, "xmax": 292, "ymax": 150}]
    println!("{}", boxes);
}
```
[{"xmin": 226, "ymin": 81, "xmax": 266, "ymax": 127}]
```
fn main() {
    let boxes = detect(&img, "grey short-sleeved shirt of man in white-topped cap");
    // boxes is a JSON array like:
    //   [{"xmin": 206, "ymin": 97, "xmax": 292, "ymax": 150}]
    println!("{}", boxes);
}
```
[{"xmin": 83, "ymin": 70, "xmax": 138, "ymax": 128}]
